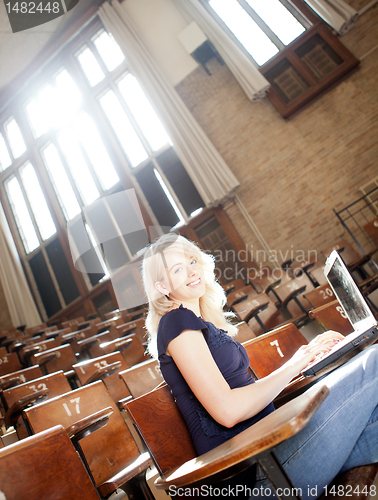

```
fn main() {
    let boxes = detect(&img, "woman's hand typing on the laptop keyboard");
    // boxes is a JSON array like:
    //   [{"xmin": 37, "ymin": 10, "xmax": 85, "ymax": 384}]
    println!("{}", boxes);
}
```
[{"xmin": 284, "ymin": 330, "xmax": 344, "ymax": 377}]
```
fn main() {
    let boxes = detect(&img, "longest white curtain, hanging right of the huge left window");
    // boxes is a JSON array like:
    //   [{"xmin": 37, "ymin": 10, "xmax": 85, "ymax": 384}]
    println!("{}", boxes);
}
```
[{"xmin": 99, "ymin": 0, "xmax": 239, "ymax": 206}]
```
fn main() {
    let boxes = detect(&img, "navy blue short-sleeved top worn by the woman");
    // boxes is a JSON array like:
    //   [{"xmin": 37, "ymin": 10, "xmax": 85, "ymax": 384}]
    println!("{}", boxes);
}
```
[{"xmin": 157, "ymin": 305, "xmax": 274, "ymax": 455}]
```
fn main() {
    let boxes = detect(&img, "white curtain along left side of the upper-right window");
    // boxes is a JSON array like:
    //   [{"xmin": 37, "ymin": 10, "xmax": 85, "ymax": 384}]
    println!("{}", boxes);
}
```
[{"xmin": 174, "ymin": 0, "xmax": 270, "ymax": 101}]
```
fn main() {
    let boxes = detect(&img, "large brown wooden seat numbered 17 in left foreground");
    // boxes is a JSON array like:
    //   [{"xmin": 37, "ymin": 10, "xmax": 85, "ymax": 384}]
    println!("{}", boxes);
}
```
[{"xmin": 24, "ymin": 381, "xmax": 149, "ymax": 494}]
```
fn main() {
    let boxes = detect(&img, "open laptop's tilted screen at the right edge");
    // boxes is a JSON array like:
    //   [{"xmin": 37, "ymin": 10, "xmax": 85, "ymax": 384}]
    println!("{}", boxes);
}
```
[{"xmin": 326, "ymin": 251, "xmax": 376, "ymax": 330}]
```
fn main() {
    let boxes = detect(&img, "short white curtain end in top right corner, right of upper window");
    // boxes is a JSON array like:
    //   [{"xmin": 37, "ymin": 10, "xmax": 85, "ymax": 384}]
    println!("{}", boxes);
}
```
[{"xmin": 305, "ymin": 0, "xmax": 358, "ymax": 35}]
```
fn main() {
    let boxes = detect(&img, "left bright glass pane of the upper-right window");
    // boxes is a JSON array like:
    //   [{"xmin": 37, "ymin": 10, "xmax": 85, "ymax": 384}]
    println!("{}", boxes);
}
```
[{"xmin": 209, "ymin": 0, "xmax": 278, "ymax": 66}]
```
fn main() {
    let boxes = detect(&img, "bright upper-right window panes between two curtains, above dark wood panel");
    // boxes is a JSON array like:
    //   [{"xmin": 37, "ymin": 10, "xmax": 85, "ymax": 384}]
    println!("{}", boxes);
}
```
[{"xmin": 203, "ymin": 0, "xmax": 309, "ymax": 66}]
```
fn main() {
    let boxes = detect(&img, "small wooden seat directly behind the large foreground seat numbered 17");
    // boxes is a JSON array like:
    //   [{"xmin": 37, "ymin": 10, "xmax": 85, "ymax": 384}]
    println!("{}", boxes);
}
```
[{"xmin": 72, "ymin": 351, "xmax": 130, "ymax": 403}]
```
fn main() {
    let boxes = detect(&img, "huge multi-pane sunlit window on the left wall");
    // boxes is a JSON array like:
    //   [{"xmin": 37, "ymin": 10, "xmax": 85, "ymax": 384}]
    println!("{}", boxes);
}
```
[{"xmin": 0, "ymin": 20, "xmax": 204, "ymax": 317}]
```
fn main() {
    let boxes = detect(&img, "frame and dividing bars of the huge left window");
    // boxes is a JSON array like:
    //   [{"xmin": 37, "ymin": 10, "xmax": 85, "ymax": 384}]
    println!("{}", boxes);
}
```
[{"xmin": 0, "ymin": 16, "xmax": 205, "ymax": 320}]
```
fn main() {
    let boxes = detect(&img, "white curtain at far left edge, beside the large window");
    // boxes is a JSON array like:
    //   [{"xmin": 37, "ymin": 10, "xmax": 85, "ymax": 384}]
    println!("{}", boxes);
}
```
[{"xmin": 0, "ymin": 204, "xmax": 41, "ymax": 326}]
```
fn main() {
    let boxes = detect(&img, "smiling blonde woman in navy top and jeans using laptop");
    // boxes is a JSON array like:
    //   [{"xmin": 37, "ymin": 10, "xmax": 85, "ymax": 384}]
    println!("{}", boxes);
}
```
[{"xmin": 142, "ymin": 234, "xmax": 378, "ymax": 498}]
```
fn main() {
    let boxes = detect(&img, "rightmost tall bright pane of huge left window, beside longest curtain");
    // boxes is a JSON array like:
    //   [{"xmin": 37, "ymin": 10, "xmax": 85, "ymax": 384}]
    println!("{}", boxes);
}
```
[{"xmin": 118, "ymin": 73, "xmax": 170, "ymax": 151}]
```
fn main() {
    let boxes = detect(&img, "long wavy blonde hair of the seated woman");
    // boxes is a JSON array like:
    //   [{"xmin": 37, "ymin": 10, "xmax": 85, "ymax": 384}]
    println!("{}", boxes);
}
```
[{"xmin": 142, "ymin": 234, "xmax": 237, "ymax": 358}]
